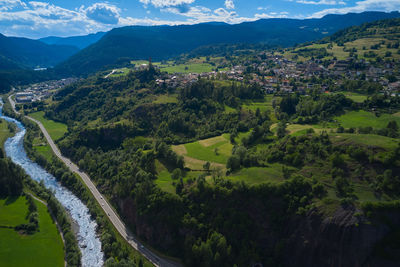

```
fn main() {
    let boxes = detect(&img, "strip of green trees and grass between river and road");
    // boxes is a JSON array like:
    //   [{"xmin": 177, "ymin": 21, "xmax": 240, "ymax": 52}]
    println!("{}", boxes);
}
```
[{"xmin": 8, "ymin": 98, "xmax": 159, "ymax": 267}]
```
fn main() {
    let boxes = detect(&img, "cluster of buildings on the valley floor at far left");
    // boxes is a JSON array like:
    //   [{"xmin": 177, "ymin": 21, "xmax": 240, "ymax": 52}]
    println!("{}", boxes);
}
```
[{"xmin": 15, "ymin": 78, "xmax": 78, "ymax": 103}]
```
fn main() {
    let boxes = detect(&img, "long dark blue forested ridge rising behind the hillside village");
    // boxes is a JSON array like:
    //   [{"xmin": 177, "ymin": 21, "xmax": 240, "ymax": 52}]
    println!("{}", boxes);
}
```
[{"xmin": 57, "ymin": 12, "xmax": 400, "ymax": 75}]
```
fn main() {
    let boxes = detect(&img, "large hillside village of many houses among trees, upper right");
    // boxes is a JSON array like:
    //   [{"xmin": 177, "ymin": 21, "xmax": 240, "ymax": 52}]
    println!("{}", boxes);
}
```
[{"xmin": 157, "ymin": 54, "xmax": 400, "ymax": 94}]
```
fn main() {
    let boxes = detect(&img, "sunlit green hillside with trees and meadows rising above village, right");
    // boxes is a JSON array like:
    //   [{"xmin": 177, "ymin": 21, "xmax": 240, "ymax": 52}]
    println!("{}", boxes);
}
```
[{"xmin": 284, "ymin": 19, "xmax": 400, "ymax": 64}]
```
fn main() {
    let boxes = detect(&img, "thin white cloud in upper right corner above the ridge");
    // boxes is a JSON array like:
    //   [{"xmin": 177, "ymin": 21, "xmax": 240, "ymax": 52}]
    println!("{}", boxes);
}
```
[{"xmin": 310, "ymin": 0, "xmax": 400, "ymax": 18}]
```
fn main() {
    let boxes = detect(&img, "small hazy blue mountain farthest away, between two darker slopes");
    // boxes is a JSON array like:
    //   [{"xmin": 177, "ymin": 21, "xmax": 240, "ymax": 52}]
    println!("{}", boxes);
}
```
[{"xmin": 39, "ymin": 32, "xmax": 106, "ymax": 49}]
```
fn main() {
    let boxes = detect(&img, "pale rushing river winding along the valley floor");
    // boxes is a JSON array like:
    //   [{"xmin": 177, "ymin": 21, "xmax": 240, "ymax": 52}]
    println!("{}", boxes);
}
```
[{"xmin": 0, "ymin": 98, "xmax": 104, "ymax": 267}]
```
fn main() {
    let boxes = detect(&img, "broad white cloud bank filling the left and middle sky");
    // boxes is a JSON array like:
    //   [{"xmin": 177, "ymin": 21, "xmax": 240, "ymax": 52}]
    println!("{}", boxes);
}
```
[{"xmin": 0, "ymin": 0, "xmax": 302, "ymax": 38}]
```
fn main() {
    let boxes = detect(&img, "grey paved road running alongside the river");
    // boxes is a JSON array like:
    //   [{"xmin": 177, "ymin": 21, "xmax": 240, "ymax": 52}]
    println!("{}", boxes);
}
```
[{"xmin": 8, "ymin": 95, "xmax": 181, "ymax": 267}]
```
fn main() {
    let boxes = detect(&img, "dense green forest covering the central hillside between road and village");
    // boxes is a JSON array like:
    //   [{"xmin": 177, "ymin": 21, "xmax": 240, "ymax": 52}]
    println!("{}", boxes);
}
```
[{"xmin": 21, "ymin": 62, "xmax": 400, "ymax": 266}]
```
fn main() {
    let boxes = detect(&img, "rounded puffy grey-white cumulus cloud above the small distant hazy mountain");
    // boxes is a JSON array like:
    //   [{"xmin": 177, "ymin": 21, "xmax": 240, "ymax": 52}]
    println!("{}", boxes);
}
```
[{"xmin": 86, "ymin": 3, "xmax": 120, "ymax": 24}]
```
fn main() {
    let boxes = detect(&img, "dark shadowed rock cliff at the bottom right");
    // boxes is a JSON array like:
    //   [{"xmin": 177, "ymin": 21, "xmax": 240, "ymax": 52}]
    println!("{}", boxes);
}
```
[{"xmin": 284, "ymin": 208, "xmax": 400, "ymax": 267}]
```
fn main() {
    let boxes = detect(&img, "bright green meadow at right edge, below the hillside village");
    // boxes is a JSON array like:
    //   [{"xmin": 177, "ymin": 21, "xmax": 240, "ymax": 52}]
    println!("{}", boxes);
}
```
[{"xmin": 335, "ymin": 110, "xmax": 400, "ymax": 128}]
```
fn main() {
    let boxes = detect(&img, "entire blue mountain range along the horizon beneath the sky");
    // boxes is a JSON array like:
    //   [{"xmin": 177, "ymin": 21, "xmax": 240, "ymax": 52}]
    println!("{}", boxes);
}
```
[{"xmin": 0, "ymin": 12, "xmax": 400, "ymax": 76}]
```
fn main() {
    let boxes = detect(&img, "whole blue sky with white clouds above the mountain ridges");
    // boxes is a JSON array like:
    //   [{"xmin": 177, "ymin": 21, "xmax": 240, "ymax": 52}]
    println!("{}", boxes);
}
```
[{"xmin": 0, "ymin": 0, "xmax": 400, "ymax": 39}]
